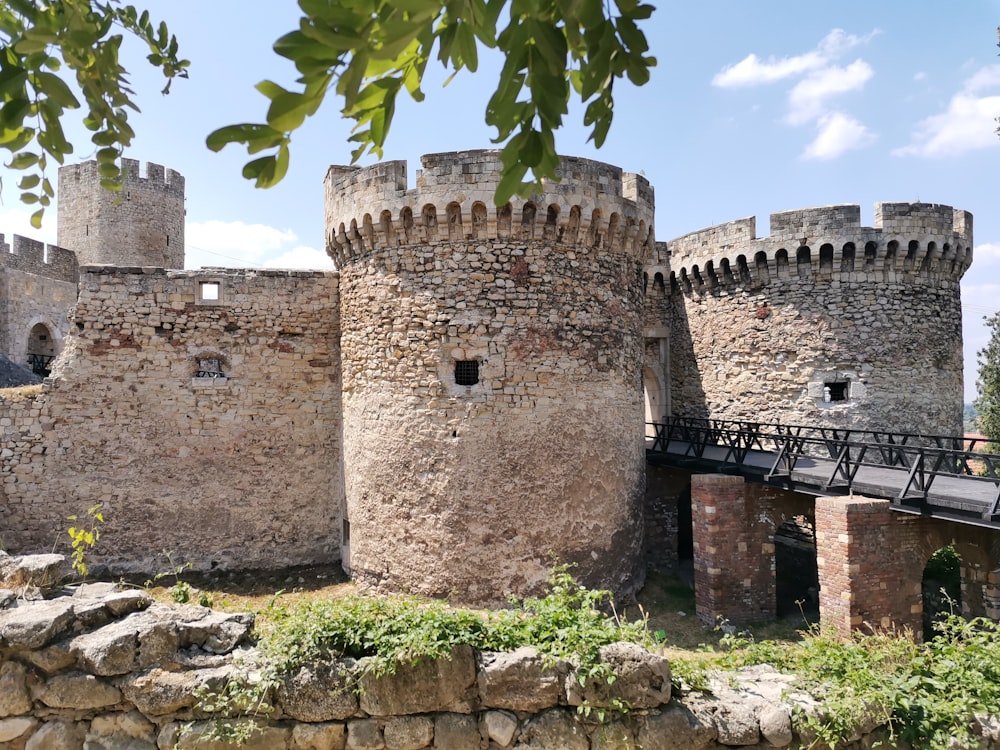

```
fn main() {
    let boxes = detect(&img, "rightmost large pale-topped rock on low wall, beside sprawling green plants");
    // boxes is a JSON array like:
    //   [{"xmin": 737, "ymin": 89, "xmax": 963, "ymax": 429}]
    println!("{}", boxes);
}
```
[{"xmin": 566, "ymin": 643, "xmax": 671, "ymax": 709}]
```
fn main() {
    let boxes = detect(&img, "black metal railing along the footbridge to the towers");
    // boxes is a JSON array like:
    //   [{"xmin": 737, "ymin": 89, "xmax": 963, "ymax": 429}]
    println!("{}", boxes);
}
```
[{"xmin": 649, "ymin": 417, "xmax": 1000, "ymax": 520}]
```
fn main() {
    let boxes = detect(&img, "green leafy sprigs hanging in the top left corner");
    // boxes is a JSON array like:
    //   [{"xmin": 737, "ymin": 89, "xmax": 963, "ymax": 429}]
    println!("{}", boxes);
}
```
[{"xmin": 0, "ymin": 0, "xmax": 188, "ymax": 228}]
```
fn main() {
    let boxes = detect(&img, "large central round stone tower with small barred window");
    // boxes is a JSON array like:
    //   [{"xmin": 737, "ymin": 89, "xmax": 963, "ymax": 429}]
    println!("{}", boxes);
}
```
[{"xmin": 326, "ymin": 151, "xmax": 653, "ymax": 604}]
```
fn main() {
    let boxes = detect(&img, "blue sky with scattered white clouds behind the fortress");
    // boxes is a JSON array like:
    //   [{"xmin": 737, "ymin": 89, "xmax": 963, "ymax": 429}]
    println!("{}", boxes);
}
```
[{"xmin": 0, "ymin": 0, "xmax": 1000, "ymax": 406}]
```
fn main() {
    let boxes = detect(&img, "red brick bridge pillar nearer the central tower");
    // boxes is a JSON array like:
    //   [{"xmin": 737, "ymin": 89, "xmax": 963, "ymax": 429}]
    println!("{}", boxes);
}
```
[{"xmin": 691, "ymin": 474, "xmax": 775, "ymax": 624}]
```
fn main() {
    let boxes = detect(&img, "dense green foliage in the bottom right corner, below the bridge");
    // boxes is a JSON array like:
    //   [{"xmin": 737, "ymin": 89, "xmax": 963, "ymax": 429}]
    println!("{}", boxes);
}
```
[{"xmin": 688, "ymin": 615, "xmax": 1000, "ymax": 750}]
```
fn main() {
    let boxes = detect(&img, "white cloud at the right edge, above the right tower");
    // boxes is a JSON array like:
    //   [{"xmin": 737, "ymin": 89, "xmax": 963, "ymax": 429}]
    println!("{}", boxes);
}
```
[{"xmin": 892, "ymin": 65, "xmax": 1000, "ymax": 157}]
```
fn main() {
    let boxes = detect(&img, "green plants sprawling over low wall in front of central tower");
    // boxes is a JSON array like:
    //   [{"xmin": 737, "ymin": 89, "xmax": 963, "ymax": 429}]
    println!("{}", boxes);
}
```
[{"xmin": 199, "ymin": 566, "xmax": 649, "ymax": 741}]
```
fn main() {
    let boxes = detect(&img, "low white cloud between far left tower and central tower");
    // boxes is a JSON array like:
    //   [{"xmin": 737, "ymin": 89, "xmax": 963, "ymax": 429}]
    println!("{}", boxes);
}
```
[{"xmin": 184, "ymin": 220, "xmax": 298, "ymax": 268}]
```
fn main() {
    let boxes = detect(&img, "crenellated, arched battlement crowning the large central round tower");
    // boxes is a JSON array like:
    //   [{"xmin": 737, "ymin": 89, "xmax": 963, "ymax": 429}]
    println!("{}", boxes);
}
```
[{"xmin": 325, "ymin": 150, "xmax": 654, "ymax": 268}]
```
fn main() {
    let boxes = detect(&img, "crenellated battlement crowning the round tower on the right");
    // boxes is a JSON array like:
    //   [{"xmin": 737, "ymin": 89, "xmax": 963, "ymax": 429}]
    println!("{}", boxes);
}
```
[{"xmin": 666, "ymin": 203, "xmax": 972, "ymax": 293}]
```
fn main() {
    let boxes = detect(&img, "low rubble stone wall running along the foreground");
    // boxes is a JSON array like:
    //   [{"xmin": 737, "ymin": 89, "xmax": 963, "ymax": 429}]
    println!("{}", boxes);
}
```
[{"xmin": 0, "ymin": 576, "xmax": 924, "ymax": 750}]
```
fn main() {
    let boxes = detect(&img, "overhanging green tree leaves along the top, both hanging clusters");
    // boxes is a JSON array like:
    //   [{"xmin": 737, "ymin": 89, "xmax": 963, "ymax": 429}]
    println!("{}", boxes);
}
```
[{"xmin": 0, "ymin": 0, "xmax": 656, "ymax": 217}]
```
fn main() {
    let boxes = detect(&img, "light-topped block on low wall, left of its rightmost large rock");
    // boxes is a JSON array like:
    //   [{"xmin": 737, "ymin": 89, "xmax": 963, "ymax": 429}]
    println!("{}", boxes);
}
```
[{"xmin": 478, "ymin": 646, "xmax": 569, "ymax": 712}]
